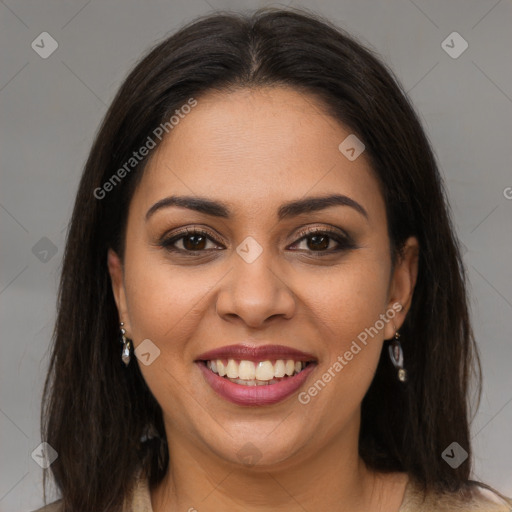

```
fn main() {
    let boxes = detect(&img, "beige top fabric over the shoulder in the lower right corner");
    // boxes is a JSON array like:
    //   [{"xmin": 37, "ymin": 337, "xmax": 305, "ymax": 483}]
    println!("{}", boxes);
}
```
[{"xmin": 399, "ymin": 481, "xmax": 512, "ymax": 512}]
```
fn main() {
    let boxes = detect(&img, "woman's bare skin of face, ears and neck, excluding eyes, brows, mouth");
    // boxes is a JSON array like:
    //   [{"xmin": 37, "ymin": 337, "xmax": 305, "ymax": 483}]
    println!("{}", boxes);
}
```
[{"xmin": 108, "ymin": 87, "xmax": 419, "ymax": 512}]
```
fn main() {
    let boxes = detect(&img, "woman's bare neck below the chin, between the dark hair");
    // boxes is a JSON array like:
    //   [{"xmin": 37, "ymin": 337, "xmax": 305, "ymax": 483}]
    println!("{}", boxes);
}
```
[{"xmin": 151, "ymin": 418, "xmax": 405, "ymax": 512}]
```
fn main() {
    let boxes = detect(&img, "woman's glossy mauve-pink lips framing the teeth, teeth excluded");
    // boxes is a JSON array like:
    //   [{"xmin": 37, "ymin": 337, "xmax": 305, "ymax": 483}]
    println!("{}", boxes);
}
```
[{"xmin": 195, "ymin": 345, "xmax": 317, "ymax": 406}]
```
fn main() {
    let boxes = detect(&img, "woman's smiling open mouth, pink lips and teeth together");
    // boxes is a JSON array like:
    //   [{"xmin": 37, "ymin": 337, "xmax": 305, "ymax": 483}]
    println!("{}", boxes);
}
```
[{"xmin": 195, "ymin": 345, "xmax": 318, "ymax": 406}]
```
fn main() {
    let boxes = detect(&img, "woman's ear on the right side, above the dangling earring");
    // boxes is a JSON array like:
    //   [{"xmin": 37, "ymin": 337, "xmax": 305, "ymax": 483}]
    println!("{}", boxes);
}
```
[{"xmin": 384, "ymin": 237, "xmax": 419, "ymax": 339}]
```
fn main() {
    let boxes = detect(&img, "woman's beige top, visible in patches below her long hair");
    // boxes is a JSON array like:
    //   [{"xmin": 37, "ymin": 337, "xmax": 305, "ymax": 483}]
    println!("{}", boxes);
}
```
[{"xmin": 34, "ymin": 477, "xmax": 512, "ymax": 512}]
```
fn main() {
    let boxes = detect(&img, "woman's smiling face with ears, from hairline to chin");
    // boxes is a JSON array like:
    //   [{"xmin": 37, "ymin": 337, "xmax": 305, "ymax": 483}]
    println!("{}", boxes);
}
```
[{"xmin": 108, "ymin": 88, "xmax": 417, "ymax": 467}]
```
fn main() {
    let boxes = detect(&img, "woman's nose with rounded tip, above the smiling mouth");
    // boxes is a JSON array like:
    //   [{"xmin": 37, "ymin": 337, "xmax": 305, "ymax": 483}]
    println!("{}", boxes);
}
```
[{"xmin": 216, "ymin": 250, "xmax": 296, "ymax": 329}]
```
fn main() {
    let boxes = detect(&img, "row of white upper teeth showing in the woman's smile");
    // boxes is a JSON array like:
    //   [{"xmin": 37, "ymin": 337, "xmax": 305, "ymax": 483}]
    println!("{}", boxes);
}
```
[{"xmin": 206, "ymin": 359, "xmax": 306, "ymax": 380}]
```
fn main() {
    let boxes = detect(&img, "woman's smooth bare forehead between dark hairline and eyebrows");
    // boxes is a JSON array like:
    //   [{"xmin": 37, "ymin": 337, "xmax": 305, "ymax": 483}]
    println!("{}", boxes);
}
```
[{"xmin": 133, "ymin": 87, "xmax": 385, "ymax": 225}]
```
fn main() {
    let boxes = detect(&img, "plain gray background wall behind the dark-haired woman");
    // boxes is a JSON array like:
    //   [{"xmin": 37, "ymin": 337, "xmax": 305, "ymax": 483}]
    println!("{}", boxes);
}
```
[{"xmin": 0, "ymin": 0, "xmax": 512, "ymax": 512}]
